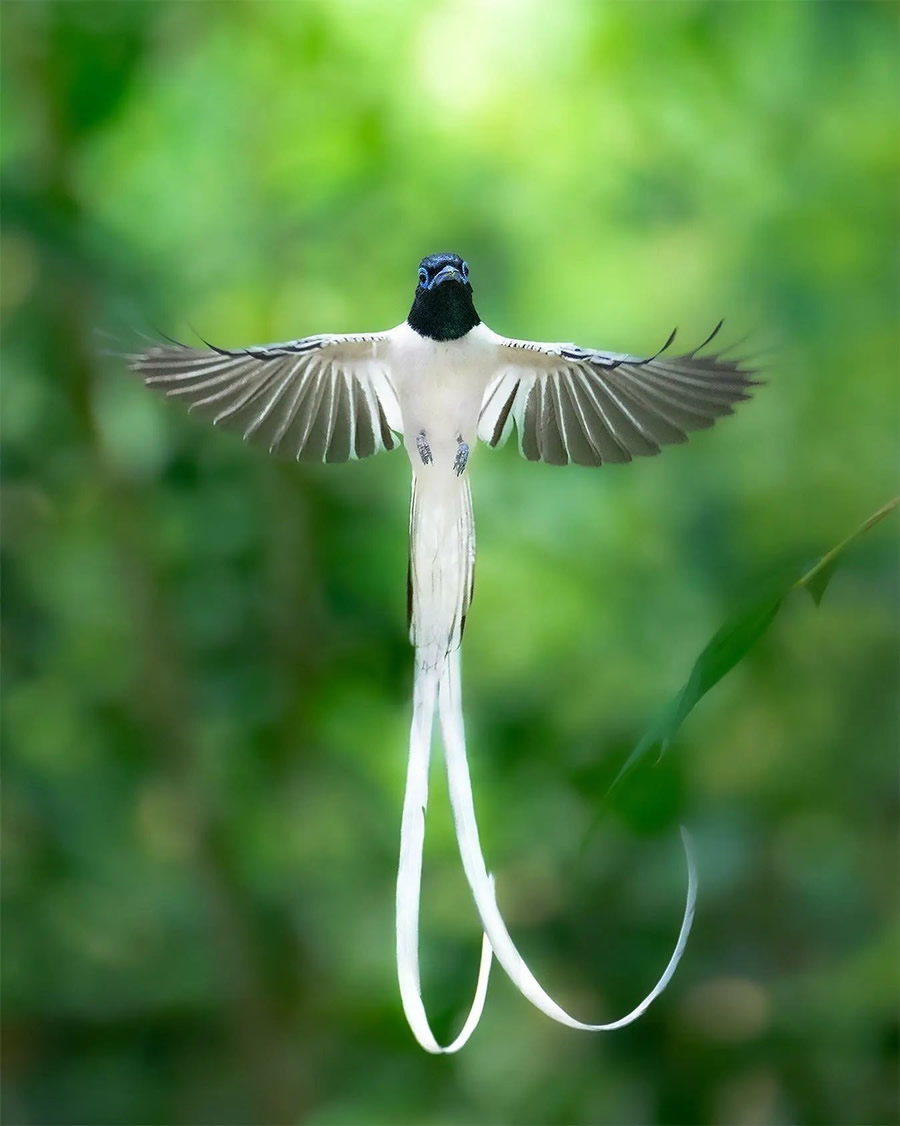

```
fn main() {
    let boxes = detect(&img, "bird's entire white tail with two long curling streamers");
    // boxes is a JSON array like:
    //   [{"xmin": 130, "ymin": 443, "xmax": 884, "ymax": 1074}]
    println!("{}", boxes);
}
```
[{"xmin": 396, "ymin": 470, "xmax": 696, "ymax": 1053}]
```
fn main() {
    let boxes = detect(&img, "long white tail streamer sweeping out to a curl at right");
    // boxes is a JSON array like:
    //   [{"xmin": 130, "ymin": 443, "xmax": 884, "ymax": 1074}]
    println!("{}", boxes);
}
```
[{"xmin": 438, "ymin": 650, "xmax": 697, "ymax": 1033}]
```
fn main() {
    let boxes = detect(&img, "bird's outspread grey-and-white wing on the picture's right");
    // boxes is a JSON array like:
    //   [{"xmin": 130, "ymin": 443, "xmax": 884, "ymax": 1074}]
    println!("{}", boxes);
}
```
[{"xmin": 478, "ymin": 322, "xmax": 759, "ymax": 465}]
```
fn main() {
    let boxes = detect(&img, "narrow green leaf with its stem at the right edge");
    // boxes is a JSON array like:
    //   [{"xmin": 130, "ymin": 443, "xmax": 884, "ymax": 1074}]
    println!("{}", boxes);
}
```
[{"xmin": 609, "ymin": 497, "xmax": 900, "ymax": 789}]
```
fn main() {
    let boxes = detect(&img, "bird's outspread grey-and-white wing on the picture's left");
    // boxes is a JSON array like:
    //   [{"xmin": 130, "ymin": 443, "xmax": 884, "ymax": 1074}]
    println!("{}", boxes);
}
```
[{"xmin": 125, "ymin": 332, "xmax": 401, "ymax": 462}]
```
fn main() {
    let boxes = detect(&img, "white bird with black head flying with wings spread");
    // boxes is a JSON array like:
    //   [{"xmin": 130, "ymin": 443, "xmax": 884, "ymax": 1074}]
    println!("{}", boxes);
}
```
[{"xmin": 125, "ymin": 252, "xmax": 759, "ymax": 1054}]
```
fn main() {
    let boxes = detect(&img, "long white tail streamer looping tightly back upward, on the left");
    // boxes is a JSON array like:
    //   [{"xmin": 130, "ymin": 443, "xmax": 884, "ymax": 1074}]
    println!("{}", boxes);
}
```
[{"xmin": 396, "ymin": 655, "xmax": 491, "ymax": 1054}]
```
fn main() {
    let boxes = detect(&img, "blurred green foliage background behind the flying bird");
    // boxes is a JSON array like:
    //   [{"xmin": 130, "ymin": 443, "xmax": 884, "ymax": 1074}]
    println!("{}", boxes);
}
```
[{"xmin": 0, "ymin": 0, "xmax": 900, "ymax": 1126}]
